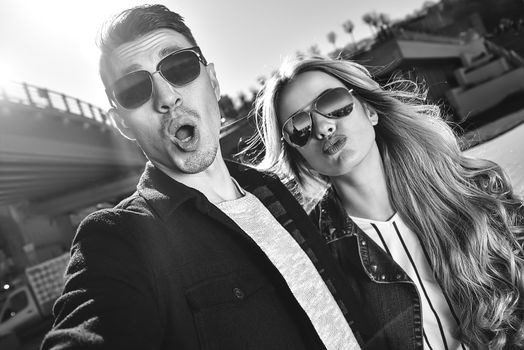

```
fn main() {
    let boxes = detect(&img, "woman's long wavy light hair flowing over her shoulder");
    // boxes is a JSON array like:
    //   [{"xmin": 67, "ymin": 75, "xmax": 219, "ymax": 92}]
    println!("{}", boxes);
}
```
[{"xmin": 247, "ymin": 56, "xmax": 524, "ymax": 349}]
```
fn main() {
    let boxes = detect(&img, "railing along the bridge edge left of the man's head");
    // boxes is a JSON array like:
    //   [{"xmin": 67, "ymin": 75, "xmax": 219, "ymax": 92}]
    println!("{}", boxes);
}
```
[{"xmin": 0, "ymin": 82, "xmax": 113, "ymax": 126}]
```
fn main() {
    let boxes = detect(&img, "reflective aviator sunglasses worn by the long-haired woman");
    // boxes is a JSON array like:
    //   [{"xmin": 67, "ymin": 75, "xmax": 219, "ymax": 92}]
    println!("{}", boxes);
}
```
[{"xmin": 282, "ymin": 87, "xmax": 354, "ymax": 147}]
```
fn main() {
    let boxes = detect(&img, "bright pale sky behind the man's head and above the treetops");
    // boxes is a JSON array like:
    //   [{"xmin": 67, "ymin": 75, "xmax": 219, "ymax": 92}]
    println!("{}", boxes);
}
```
[{"xmin": 0, "ymin": 0, "xmax": 425, "ymax": 109}]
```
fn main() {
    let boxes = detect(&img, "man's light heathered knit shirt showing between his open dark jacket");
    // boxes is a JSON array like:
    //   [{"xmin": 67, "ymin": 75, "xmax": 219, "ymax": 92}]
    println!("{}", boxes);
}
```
[{"xmin": 216, "ymin": 187, "xmax": 360, "ymax": 350}]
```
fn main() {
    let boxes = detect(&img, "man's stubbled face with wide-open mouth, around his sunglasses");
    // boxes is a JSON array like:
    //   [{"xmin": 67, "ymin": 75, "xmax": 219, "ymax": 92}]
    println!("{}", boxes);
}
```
[{"xmin": 110, "ymin": 29, "xmax": 220, "ymax": 176}]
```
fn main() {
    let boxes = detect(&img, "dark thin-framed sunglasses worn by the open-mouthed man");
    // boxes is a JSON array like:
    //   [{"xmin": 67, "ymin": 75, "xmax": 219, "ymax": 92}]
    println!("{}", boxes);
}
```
[{"xmin": 108, "ymin": 46, "xmax": 207, "ymax": 109}]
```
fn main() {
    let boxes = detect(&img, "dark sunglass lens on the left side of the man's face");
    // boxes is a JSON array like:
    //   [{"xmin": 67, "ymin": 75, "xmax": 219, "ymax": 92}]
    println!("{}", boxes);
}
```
[{"xmin": 113, "ymin": 71, "xmax": 152, "ymax": 109}]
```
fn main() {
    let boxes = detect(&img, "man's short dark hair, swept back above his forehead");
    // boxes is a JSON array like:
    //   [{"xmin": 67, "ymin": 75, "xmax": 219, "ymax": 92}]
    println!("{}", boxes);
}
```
[{"xmin": 98, "ymin": 5, "xmax": 197, "ymax": 89}]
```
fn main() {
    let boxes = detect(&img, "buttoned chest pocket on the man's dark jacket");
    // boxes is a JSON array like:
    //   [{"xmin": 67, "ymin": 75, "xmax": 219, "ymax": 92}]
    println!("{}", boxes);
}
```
[{"xmin": 186, "ymin": 273, "xmax": 302, "ymax": 350}]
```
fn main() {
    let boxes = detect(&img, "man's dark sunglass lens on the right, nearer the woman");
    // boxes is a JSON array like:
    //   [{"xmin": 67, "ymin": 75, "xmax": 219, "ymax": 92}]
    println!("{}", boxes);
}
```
[{"xmin": 160, "ymin": 51, "xmax": 200, "ymax": 86}]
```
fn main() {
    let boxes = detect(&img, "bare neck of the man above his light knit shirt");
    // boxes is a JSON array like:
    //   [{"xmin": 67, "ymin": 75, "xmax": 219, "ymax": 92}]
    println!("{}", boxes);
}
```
[{"xmin": 158, "ymin": 156, "xmax": 242, "ymax": 203}]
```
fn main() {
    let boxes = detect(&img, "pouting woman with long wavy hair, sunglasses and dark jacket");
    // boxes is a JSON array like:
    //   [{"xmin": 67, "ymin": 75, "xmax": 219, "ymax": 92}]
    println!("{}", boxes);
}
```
[{"xmin": 246, "ymin": 57, "xmax": 524, "ymax": 349}]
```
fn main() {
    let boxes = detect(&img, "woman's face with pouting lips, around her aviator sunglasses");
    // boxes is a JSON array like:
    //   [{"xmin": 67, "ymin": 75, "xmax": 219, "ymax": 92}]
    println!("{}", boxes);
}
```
[{"xmin": 277, "ymin": 71, "xmax": 378, "ymax": 177}]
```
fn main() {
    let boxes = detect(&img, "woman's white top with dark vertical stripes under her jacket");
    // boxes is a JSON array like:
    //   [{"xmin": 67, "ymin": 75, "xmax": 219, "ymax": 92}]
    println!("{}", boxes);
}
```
[{"xmin": 350, "ymin": 214, "xmax": 466, "ymax": 350}]
